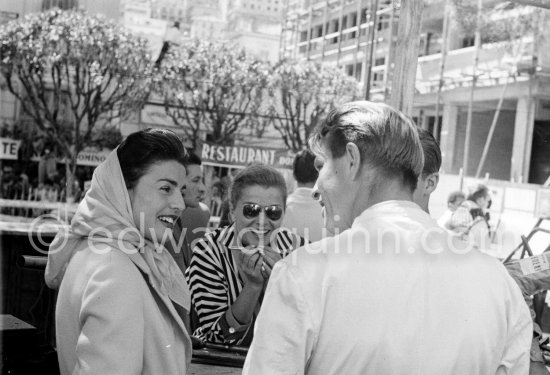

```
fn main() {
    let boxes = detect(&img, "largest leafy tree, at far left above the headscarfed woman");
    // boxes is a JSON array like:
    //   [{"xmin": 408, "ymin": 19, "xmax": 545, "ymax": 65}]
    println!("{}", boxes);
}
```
[{"xmin": 0, "ymin": 9, "xmax": 152, "ymax": 200}]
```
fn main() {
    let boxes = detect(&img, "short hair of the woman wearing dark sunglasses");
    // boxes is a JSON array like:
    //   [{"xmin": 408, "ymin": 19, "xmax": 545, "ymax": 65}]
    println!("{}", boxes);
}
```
[{"xmin": 229, "ymin": 164, "xmax": 287, "ymax": 208}]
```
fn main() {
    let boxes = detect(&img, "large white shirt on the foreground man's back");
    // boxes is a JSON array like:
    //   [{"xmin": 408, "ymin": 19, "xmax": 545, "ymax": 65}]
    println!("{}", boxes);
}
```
[{"xmin": 243, "ymin": 201, "xmax": 532, "ymax": 375}]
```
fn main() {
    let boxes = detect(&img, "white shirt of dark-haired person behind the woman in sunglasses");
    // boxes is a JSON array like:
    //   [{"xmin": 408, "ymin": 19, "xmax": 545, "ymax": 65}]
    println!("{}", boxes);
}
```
[{"xmin": 281, "ymin": 187, "xmax": 324, "ymax": 242}]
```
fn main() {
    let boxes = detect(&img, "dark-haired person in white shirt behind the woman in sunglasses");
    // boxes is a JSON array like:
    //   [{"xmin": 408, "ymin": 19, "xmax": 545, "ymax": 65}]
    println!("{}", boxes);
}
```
[{"xmin": 281, "ymin": 150, "xmax": 324, "ymax": 242}]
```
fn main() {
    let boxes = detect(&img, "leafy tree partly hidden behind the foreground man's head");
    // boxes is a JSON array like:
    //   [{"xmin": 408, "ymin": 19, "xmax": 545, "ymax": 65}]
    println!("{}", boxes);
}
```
[{"xmin": 268, "ymin": 60, "xmax": 359, "ymax": 151}]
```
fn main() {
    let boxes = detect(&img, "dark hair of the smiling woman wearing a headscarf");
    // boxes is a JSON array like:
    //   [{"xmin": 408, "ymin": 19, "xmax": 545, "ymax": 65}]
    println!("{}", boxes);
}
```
[{"xmin": 117, "ymin": 128, "xmax": 187, "ymax": 189}]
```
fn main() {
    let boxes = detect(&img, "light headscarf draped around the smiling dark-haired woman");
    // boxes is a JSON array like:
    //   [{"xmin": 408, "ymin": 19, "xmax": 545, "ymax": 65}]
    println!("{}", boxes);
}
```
[{"xmin": 45, "ymin": 149, "xmax": 191, "ymax": 312}]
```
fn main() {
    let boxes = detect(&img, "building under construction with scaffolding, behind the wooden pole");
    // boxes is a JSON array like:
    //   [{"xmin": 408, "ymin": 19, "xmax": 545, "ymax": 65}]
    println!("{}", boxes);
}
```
[{"xmin": 280, "ymin": 0, "xmax": 550, "ymax": 183}]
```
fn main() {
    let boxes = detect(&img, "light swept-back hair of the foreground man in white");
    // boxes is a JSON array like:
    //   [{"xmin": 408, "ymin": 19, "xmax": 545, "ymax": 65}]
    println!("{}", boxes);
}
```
[{"xmin": 310, "ymin": 101, "xmax": 424, "ymax": 193}]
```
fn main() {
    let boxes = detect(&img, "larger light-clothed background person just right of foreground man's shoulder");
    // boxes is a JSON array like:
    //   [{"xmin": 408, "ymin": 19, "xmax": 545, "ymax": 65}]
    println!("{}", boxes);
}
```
[{"xmin": 449, "ymin": 184, "xmax": 491, "ymax": 249}]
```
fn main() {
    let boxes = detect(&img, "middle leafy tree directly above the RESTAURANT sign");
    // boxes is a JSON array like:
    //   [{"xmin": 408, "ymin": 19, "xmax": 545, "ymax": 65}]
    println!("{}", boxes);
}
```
[{"xmin": 156, "ymin": 40, "xmax": 269, "ymax": 147}]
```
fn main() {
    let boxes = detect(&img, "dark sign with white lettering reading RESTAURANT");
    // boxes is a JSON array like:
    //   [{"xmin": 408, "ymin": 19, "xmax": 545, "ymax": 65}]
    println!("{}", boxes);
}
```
[{"xmin": 200, "ymin": 142, "xmax": 294, "ymax": 169}]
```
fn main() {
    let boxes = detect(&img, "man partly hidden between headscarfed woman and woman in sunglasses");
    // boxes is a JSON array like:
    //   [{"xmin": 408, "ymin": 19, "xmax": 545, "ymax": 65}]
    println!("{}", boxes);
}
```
[{"xmin": 166, "ymin": 152, "xmax": 210, "ymax": 273}]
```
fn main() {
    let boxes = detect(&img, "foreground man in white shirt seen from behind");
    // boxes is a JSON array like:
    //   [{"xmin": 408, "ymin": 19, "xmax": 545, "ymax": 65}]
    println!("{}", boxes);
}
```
[{"xmin": 243, "ymin": 102, "xmax": 532, "ymax": 375}]
